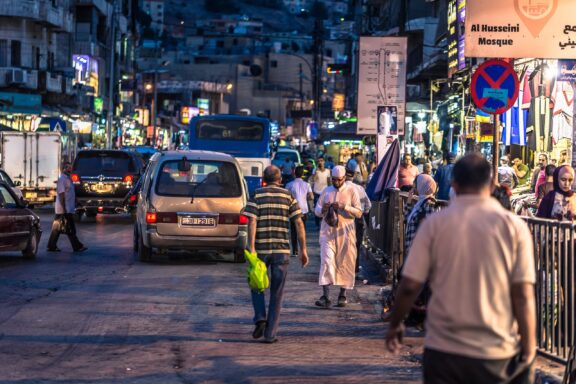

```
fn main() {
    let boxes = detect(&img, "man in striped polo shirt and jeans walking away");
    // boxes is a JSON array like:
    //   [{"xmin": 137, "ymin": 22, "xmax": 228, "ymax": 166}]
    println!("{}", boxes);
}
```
[{"xmin": 244, "ymin": 165, "xmax": 308, "ymax": 343}]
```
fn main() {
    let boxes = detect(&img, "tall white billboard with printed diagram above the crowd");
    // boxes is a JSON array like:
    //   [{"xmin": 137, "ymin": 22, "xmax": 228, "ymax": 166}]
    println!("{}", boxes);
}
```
[{"xmin": 356, "ymin": 36, "xmax": 408, "ymax": 135}]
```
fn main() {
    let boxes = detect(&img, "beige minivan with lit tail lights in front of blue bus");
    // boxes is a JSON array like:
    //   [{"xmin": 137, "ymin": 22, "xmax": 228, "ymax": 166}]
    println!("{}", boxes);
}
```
[{"xmin": 134, "ymin": 150, "xmax": 248, "ymax": 262}]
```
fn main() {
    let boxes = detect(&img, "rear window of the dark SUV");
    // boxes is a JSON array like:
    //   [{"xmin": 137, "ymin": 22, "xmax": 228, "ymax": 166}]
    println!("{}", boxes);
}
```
[{"xmin": 74, "ymin": 151, "xmax": 136, "ymax": 176}]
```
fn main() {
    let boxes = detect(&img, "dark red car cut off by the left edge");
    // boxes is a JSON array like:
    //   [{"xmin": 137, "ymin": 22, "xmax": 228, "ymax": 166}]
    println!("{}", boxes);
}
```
[{"xmin": 0, "ymin": 182, "xmax": 42, "ymax": 259}]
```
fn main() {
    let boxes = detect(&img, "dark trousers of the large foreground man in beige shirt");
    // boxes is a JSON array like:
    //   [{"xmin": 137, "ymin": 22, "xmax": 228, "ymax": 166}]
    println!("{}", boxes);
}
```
[{"xmin": 423, "ymin": 348, "xmax": 534, "ymax": 384}]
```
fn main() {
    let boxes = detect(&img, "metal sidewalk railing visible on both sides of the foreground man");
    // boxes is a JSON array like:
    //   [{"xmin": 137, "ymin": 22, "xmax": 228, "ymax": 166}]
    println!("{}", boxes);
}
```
[{"xmin": 366, "ymin": 189, "xmax": 576, "ymax": 363}]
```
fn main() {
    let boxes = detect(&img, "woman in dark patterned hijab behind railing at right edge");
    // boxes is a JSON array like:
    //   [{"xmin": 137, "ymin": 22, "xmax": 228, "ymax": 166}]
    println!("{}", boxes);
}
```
[{"xmin": 536, "ymin": 165, "xmax": 576, "ymax": 221}]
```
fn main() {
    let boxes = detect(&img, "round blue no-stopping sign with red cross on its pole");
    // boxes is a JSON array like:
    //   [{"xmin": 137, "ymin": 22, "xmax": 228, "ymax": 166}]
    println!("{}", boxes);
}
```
[{"xmin": 470, "ymin": 60, "xmax": 519, "ymax": 183}]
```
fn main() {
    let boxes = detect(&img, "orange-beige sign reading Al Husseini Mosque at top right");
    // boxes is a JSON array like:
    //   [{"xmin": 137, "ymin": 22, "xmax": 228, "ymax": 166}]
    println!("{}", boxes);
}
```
[{"xmin": 465, "ymin": 0, "xmax": 576, "ymax": 59}]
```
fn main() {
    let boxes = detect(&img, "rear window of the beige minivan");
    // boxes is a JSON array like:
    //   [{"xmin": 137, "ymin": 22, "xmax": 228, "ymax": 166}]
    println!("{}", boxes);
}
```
[{"xmin": 156, "ymin": 160, "xmax": 242, "ymax": 197}]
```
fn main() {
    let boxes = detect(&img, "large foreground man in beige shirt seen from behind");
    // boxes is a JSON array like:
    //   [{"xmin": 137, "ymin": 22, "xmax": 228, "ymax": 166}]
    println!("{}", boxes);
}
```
[{"xmin": 386, "ymin": 154, "xmax": 536, "ymax": 384}]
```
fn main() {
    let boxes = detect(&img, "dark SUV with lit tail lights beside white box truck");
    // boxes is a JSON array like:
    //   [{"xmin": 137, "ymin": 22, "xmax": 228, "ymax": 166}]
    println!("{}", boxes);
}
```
[{"xmin": 71, "ymin": 150, "xmax": 143, "ymax": 217}]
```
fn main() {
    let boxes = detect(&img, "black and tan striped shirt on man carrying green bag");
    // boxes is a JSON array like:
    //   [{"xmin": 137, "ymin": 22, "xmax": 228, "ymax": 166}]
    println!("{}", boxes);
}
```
[{"xmin": 244, "ymin": 186, "xmax": 302, "ymax": 254}]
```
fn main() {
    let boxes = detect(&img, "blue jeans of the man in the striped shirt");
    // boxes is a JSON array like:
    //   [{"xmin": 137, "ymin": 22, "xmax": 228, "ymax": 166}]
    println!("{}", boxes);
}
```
[{"xmin": 251, "ymin": 253, "xmax": 290, "ymax": 339}]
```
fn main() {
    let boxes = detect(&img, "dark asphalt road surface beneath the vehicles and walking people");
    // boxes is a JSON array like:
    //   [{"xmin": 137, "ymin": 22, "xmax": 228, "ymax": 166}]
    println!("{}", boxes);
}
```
[{"xmin": 0, "ymin": 211, "xmax": 421, "ymax": 384}]
